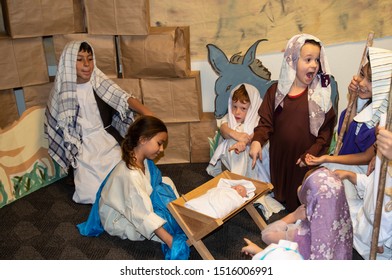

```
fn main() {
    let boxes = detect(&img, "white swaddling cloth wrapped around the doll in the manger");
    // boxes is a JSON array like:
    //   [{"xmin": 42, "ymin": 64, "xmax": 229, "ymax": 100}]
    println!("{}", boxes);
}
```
[{"xmin": 185, "ymin": 178, "xmax": 256, "ymax": 218}]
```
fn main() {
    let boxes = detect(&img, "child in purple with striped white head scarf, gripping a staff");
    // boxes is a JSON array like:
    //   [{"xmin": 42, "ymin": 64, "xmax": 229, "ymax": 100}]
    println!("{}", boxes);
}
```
[{"xmin": 305, "ymin": 47, "xmax": 392, "ymax": 208}]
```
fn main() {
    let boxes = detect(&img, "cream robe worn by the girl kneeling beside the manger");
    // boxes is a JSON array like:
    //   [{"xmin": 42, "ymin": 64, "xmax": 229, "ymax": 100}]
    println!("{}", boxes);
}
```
[{"xmin": 99, "ymin": 161, "xmax": 176, "ymax": 242}]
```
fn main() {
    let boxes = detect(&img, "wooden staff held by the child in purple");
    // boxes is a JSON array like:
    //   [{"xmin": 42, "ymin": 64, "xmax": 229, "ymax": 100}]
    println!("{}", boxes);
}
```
[{"xmin": 334, "ymin": 31, "xmax": 374, "ymax": 156}]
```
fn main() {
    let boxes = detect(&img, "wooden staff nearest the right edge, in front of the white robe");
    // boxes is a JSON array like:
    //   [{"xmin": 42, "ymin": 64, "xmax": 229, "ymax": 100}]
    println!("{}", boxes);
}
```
[{"xmin": 369, "ymin": 77, "xmax": 392, "ymax": 260}]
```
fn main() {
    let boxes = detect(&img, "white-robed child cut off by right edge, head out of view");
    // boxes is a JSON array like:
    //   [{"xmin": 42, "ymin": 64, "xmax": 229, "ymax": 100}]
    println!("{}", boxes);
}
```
[{"xmin": 335, "ymin": 112, "xmax": 392, "ymax": 260}]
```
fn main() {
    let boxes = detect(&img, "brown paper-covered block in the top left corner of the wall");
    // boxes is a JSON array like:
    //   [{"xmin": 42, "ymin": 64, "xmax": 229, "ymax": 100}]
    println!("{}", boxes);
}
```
[{"xmin": 1, "ymin": 0, "xmax": 77, "ymax": 38}]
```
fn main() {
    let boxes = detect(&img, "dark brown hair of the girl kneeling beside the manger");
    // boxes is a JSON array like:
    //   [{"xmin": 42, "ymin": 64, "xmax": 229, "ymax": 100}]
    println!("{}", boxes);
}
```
[{"xmin": 121, "ymin": 116, "xmax": 167, "ymax": 169}]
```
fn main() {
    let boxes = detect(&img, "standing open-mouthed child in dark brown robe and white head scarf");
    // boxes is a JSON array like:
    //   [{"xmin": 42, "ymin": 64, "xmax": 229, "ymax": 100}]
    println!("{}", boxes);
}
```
[{"xmin": 249, "ymin": 34, "xmax": 336, "ymax": 211}]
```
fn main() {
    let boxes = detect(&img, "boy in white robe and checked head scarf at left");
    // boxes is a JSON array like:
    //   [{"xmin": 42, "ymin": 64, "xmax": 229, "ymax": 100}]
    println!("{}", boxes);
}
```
[{"xmin": 45, "ymin": 41, "xmax": 151, "ymax": 203}]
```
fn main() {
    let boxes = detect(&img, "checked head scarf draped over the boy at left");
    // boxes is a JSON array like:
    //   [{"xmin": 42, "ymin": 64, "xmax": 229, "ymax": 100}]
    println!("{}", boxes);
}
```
[{"xmin": 45, "ymin": 41, "xmax": 134, "ymax": 169}]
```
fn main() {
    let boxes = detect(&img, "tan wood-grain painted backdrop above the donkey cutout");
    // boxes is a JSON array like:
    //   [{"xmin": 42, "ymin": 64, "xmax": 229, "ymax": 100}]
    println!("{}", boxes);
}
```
[{"xmin": 150, "ymin": 0, "xmax": 392, "ymax": 60}]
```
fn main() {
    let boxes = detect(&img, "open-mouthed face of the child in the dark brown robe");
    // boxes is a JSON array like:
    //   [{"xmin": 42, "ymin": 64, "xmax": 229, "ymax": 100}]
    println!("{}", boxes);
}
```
[{"xmin": 295, "ymin": 43, "xmax": 320, "ymax": 88}]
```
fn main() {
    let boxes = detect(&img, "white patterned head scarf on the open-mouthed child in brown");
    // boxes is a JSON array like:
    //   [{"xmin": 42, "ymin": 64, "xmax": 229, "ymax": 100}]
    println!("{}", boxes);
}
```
[{"xmin": 275, "ymin": 34, "xmax": 332, "ymax": 136}]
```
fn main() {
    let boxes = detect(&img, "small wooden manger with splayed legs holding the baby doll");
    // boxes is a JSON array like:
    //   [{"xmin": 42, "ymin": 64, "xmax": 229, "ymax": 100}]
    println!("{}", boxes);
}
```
[{"xmin": 167, "ymin": 171, "xmax": 273, "ymax": 260}]
